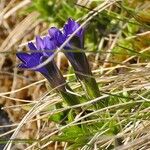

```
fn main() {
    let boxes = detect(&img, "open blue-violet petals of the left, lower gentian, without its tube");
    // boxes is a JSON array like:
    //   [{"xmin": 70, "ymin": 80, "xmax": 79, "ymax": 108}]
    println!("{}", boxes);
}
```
[{"xmin": 17, "ymin": 36, "xmax": 56, "ymax": 73}]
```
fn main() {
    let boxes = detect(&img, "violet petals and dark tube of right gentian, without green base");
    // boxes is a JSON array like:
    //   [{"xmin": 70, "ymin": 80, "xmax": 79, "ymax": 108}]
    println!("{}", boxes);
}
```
[{"xmin": 49, "ymin": 19, "xmax": 92, "ymax": 80}]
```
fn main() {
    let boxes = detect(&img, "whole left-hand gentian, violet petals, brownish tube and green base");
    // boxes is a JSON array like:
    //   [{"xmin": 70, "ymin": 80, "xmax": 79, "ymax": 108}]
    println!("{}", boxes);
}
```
[{"xmin": 17, "ymin": 36, "xmax": 79, "ymax": 105}]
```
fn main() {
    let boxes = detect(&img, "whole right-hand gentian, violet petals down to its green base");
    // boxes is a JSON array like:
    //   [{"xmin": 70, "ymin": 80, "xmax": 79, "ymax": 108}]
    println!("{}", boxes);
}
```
[{"xmin": 49, "ymin": 19, "xmax": 100, "ymax": 98}]
